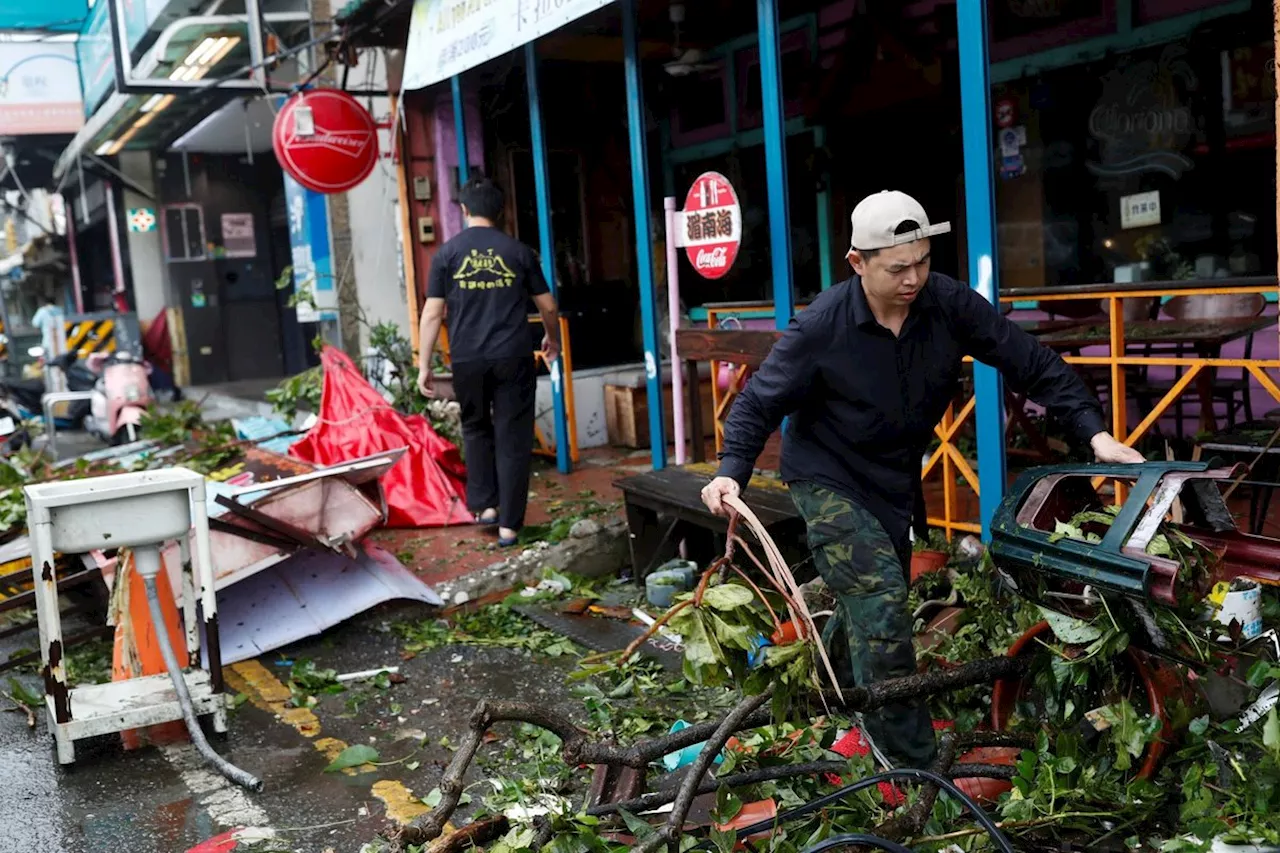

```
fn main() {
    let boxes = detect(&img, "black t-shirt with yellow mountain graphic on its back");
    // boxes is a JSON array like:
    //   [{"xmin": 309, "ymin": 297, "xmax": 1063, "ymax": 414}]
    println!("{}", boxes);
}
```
[{"xmin": 426, "ymin": 225, "xmax": 548, "ymax": 364}]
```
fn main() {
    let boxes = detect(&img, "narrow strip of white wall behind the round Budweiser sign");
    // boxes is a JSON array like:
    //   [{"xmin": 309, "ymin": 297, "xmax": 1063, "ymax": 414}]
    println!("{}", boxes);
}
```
[{"xmin": 347, "ymin": 50, "xmax": 410, "ymax": 345}]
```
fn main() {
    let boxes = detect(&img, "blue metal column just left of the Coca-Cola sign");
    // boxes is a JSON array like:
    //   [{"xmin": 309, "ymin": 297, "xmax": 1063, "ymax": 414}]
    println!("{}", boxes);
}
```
[{"xmin": 622, "ymin": 0, "xmax": 678, "ymax": 470}]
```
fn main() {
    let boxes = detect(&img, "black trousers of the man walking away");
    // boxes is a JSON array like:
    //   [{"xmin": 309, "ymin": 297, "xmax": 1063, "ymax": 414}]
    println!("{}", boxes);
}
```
[{"xmin": 453, "ymin": 356, "xmax": 538, "ymax": 530}]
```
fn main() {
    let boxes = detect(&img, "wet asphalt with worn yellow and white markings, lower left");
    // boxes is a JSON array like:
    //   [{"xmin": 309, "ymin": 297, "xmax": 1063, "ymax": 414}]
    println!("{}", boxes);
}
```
[{"xmin": 0, "ymin": 596, "xmax": 581, "ymax": 853}]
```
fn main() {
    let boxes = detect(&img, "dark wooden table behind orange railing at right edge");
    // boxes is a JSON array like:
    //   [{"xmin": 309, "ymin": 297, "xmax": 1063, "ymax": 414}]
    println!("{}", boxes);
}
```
[{"xmin": 1036, "ymin": 316, "xmax": 1276, "ymax": 433}]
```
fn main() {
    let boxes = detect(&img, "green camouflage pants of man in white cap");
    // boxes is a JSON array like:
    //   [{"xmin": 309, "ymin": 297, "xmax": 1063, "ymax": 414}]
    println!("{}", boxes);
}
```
[{"xmin": 788, "ymin": 482, "xmax": 937, "ymax": 768}]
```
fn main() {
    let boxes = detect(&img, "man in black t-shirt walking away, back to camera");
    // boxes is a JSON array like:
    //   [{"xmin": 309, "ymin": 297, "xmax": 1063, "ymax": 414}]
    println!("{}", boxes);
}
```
[{"xmin": 419, "ymin": 177, "xmax": 559, "ymax": 546}]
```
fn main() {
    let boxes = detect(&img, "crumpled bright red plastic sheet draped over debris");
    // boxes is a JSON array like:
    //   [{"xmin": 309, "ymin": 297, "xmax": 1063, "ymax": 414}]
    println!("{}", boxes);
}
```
[{"xmin": 289, "ymin": 347, "xmax": 471, "ymax": 528}]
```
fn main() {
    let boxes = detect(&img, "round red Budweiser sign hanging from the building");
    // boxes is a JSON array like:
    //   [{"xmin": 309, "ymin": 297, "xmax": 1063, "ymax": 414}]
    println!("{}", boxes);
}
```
[{"xmin": 271, "ymin": 88, "xmax": 378, "ymax": 192}]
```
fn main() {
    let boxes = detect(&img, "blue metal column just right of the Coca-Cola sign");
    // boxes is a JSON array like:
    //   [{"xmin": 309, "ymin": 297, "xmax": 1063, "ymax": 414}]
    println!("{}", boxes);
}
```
[{"xmin": 755, "ymin": 0, "xmax": 795, "ymax": 329}]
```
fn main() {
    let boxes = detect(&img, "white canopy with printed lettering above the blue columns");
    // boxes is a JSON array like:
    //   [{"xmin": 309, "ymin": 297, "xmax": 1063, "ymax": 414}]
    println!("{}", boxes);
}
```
[{"xmin": 404, "ymin": 0, "xmax": 613, "ymax": 90}]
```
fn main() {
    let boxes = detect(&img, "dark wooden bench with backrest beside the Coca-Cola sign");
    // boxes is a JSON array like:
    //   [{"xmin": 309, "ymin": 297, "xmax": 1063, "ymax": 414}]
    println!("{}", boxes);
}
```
[{"xmin": 614, "ymin": 329, "xmax": 805, "ymax": 579}]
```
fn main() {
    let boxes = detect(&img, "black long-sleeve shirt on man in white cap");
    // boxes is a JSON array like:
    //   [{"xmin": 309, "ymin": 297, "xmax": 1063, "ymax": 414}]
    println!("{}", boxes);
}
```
[{"xmin": 719, "ymin": 273, "xmax": 1106, "ymax": 540}]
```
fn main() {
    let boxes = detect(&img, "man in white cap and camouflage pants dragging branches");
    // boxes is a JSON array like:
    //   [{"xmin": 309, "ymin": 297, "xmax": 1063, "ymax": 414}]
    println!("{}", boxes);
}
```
[{"xmin": 703, "ymin": 191, "xmax": 1143, "ymax": 767}]
